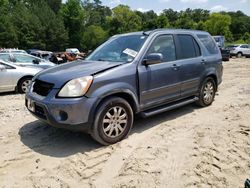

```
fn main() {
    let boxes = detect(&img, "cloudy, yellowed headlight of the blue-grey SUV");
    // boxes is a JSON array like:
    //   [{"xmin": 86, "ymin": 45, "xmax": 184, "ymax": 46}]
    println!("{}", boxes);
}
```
[{"xmin": 58, "ymin": 76, "xmax": 93, "ymax": 97}]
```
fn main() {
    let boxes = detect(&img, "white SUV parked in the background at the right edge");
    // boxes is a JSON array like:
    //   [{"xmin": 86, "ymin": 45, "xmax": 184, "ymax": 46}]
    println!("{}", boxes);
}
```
[{"xmin": 227, "ymin": 44, "xmax": 250, "ymax": 57}]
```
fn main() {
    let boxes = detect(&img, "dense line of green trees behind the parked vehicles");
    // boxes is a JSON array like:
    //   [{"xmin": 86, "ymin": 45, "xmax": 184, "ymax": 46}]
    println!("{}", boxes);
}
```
[{"xmin": 0, "ymin": 0, "xmax": 250, "ymax": 51}]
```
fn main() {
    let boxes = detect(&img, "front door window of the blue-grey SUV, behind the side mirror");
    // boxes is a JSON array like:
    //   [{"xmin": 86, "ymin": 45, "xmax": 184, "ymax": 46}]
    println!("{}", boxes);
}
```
[{"xmin": 147, "ymin": 35, "xmax": 176, "ymax": 62}]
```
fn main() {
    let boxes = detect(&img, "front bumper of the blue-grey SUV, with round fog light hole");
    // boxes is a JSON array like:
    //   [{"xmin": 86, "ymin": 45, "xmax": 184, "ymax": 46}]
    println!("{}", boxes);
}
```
[{"xmin": 25, "ymin": 89, "xmax": 96, "ymax": 132}]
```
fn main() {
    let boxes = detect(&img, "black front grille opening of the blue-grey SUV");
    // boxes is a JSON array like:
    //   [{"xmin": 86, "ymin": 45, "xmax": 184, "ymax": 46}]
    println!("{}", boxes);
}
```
[{"xmin": 33, "ymin": 80, "xmax": 54, "ymax": 97}]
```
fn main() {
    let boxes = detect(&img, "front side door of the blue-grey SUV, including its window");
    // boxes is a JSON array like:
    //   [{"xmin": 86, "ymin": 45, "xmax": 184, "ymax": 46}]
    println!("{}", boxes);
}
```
[{"xmin": 138, "ymin": 35, "xmax": 181, "ymax": 109}]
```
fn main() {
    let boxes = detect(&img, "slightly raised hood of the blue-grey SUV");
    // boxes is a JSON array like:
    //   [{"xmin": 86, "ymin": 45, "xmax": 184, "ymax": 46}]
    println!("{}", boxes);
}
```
[{"xmin": 33, "ymin": 60, "xmax": 122, "ymax": 89}]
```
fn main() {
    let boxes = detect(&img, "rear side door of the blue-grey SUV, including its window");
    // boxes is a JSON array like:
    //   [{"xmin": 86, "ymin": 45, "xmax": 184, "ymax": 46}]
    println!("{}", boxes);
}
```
[{"xmin": 176, "ymin": 34, "xmax": 205, "ymax": 98}]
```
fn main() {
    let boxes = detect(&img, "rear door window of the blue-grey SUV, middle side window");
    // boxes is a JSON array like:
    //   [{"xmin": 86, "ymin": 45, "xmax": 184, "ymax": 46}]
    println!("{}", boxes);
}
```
[{"xmin": 177, "ymin": 35, "xmax": 201, "ymax": 59}]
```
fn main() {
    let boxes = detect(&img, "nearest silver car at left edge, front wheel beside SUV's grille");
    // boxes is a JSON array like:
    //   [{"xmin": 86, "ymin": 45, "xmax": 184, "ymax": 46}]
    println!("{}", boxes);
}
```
[{"xmin": 0, "ymin": 60, "xmax": 42, "ymax": 93}]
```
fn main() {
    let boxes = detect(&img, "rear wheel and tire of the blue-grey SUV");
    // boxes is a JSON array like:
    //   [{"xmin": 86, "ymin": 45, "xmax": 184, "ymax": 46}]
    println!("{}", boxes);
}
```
[{"xmin": 196, "ymin": 77, "xmax": 216, "ymax": 107}]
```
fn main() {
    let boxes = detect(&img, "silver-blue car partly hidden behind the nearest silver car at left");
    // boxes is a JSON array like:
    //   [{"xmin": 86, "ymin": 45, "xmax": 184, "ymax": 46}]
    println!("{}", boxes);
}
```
[{"xmin": 0, "ymin": 53, "xmax": 55, "ymax": 69}]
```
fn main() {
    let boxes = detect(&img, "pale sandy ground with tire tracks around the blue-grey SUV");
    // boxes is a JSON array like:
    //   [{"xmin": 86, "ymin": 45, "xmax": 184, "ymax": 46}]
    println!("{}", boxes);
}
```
[{"xmin": 0, "ymin": 59, "xmax": 250, "ymax": 188}]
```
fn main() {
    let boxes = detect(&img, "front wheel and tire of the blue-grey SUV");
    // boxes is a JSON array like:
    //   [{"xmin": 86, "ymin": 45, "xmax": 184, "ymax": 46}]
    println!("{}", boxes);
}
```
[{"xmin": 91, "ymin": 97, "xmax": 134, "ymax": 145}]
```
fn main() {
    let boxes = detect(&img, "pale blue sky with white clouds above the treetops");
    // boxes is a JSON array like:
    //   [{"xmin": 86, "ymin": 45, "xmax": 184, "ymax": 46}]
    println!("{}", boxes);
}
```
[{"xmin": 98, "ymin": 0, "xmax": 250, "ymax": 16}]
